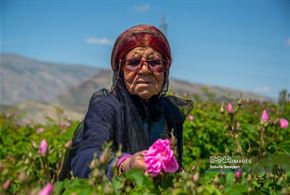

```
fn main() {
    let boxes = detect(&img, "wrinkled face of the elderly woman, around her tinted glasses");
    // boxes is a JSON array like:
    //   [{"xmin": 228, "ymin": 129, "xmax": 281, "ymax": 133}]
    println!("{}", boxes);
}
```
[{"xmin": 122, "ymin": 47, "xmax": 164, "ymax": 100}]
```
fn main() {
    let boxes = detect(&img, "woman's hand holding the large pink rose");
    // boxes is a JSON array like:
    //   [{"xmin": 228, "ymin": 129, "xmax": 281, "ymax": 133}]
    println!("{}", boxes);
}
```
[{"xmin": 120, "ymin": 150, "xmax": 147, "ymax": 172}]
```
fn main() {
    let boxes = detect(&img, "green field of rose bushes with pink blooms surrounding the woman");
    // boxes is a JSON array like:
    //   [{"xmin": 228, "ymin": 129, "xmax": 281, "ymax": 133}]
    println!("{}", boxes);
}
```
[{"xmin": 0, "ymin": 90, "xmax": 290, "ymax": 195}]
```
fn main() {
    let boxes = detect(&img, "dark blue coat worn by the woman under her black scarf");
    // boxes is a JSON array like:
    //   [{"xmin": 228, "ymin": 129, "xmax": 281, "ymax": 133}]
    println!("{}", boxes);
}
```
[{"xmin": 71, "ymin": 95, "xmax": 185, "ymax": 178}]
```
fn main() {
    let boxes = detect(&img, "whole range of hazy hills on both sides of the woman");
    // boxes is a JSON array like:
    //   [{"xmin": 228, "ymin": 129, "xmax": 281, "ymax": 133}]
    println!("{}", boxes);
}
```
[{"xmin": 0, "ymin": 54, "xmax": 269, "ymax": 121}]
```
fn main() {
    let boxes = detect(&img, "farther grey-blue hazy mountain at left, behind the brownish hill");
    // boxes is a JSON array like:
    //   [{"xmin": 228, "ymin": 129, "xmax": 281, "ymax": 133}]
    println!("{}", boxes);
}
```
[{"xmin": 0, "ymin": 54, "xmax": 98, "ymax": 105}]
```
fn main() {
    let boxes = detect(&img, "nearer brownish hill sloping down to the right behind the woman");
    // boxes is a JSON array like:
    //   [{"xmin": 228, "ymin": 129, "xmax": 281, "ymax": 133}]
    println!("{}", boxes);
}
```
[{"xmin": 58, "ymin": 72, "xmax": 270, "ymax": 113}]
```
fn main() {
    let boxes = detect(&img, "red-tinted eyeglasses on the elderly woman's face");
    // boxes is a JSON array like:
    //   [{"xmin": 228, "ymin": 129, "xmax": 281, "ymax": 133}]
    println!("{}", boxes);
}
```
[{"xmin": 122, "ymin": 58, "xmax": 170, "ymax": 72}]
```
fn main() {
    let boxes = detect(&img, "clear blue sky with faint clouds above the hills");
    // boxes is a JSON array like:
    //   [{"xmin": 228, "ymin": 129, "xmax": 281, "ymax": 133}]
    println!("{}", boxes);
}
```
[{"xmin": 0, "ymin": 0, "xmax": 290, "ymax": 98}]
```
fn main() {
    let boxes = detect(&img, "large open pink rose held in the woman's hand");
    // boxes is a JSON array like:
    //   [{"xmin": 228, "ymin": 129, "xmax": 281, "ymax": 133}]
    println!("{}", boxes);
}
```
[{"xmin": 144, "ymin": 139, "xmax": 179, "ymax": 176}]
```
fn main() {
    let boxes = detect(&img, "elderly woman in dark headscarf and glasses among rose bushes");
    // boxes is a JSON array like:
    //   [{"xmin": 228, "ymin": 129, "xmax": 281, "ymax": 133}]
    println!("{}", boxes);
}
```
[{"xmin": 67, "ymin": 25, "xmax": 192, "ymax": 178}]
